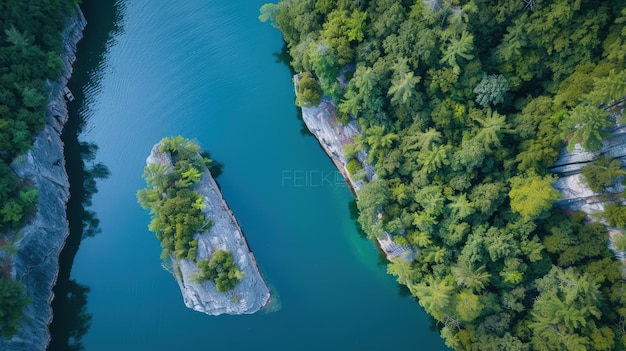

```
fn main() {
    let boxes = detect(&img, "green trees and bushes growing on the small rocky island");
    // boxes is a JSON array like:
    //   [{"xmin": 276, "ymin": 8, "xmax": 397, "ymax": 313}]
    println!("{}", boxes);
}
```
[{"xmin": 137, "ymin": 136, "xmax": 243, "ymax": 292}]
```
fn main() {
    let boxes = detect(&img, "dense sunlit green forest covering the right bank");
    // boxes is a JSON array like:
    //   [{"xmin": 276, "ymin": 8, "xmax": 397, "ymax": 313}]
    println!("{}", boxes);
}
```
[{"xmin": 260, "ymin": 0, "xmax": 626, "ymax": 351}]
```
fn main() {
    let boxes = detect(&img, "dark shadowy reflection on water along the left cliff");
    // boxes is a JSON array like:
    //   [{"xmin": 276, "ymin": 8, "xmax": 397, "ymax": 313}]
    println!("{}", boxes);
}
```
[{"xmin": 48, "ymin": 2, "xmax": 121, "ymax": 351}]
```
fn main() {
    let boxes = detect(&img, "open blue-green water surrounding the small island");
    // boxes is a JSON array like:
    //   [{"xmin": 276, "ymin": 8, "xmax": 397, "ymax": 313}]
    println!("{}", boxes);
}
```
[{"xmin": 55, "ymin": 0, "xmax": 446, "ymax": 351}]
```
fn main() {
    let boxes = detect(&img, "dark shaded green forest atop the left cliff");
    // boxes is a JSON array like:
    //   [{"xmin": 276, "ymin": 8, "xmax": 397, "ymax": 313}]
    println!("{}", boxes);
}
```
[{"xmin": 0, "ymin": 0, "xmax": 77, "ymax": 337}]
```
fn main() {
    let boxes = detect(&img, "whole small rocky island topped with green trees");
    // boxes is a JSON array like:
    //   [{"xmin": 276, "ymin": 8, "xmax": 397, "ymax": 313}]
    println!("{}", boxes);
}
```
[{"xmin": 137, "ymin": 136, "xmax": 270, "ymax": 315}]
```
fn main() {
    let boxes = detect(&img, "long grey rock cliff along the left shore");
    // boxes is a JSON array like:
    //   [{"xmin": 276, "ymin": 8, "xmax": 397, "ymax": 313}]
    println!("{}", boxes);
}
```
[{"xmin": 0, "ymin": 7, "xmax": 87, "ymax": 351}]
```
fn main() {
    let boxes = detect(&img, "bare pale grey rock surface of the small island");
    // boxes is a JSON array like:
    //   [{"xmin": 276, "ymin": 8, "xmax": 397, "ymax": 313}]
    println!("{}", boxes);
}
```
[{"xmin": 146, "ymin": 143, "xmax": 270, "ymax": 315}]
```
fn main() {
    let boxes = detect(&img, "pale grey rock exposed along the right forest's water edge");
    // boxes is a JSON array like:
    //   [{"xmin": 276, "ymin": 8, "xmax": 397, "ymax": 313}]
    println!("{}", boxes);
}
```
[{"xmin": 294, "ymin": 75, "xmax": 415, "ymax": 260}]
